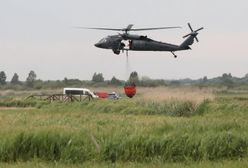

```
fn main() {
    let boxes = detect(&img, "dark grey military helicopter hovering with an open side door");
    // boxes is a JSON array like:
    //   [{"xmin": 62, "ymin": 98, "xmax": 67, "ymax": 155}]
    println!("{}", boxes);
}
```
[{"xmin": 78, "ymin": 23, "xmax": 203, "ymax": 58}]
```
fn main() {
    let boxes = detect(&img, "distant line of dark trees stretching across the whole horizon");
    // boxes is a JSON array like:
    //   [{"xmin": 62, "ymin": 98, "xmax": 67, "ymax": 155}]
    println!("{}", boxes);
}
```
[{"xmin": 0, "ymin": 70, "xmax": 248, "ymax": 89}]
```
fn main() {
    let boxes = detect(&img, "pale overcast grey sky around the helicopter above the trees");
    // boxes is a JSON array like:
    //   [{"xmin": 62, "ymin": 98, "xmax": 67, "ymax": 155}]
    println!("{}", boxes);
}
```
[{"xmin": 0, "ymin": 0, "xmax": 248, "ymax": 80}]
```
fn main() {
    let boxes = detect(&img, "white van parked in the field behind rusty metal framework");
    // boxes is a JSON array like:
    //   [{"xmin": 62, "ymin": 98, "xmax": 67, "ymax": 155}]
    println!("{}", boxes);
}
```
[{"xmin": 63, "ymin": 88, "xmax": 98, "ymax": 98}]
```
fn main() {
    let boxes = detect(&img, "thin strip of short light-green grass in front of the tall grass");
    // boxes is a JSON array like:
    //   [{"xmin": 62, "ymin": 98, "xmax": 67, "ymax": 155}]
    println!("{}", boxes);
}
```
[{"xmin": 0, "ymin": 160, "xmax": 248, "ymax": 168}]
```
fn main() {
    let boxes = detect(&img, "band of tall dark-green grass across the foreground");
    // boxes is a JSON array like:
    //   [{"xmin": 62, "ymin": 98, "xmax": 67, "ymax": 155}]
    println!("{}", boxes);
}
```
[{"xmin": 0, "ymin": 132, "xmax": 248, "ymax": 163}]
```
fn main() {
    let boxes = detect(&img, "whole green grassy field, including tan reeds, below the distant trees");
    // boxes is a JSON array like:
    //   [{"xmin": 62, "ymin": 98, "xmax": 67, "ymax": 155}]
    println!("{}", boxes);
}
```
[{"xmin": 0, "ymin": 87, "xmax": 248, "ymax": 168}]
